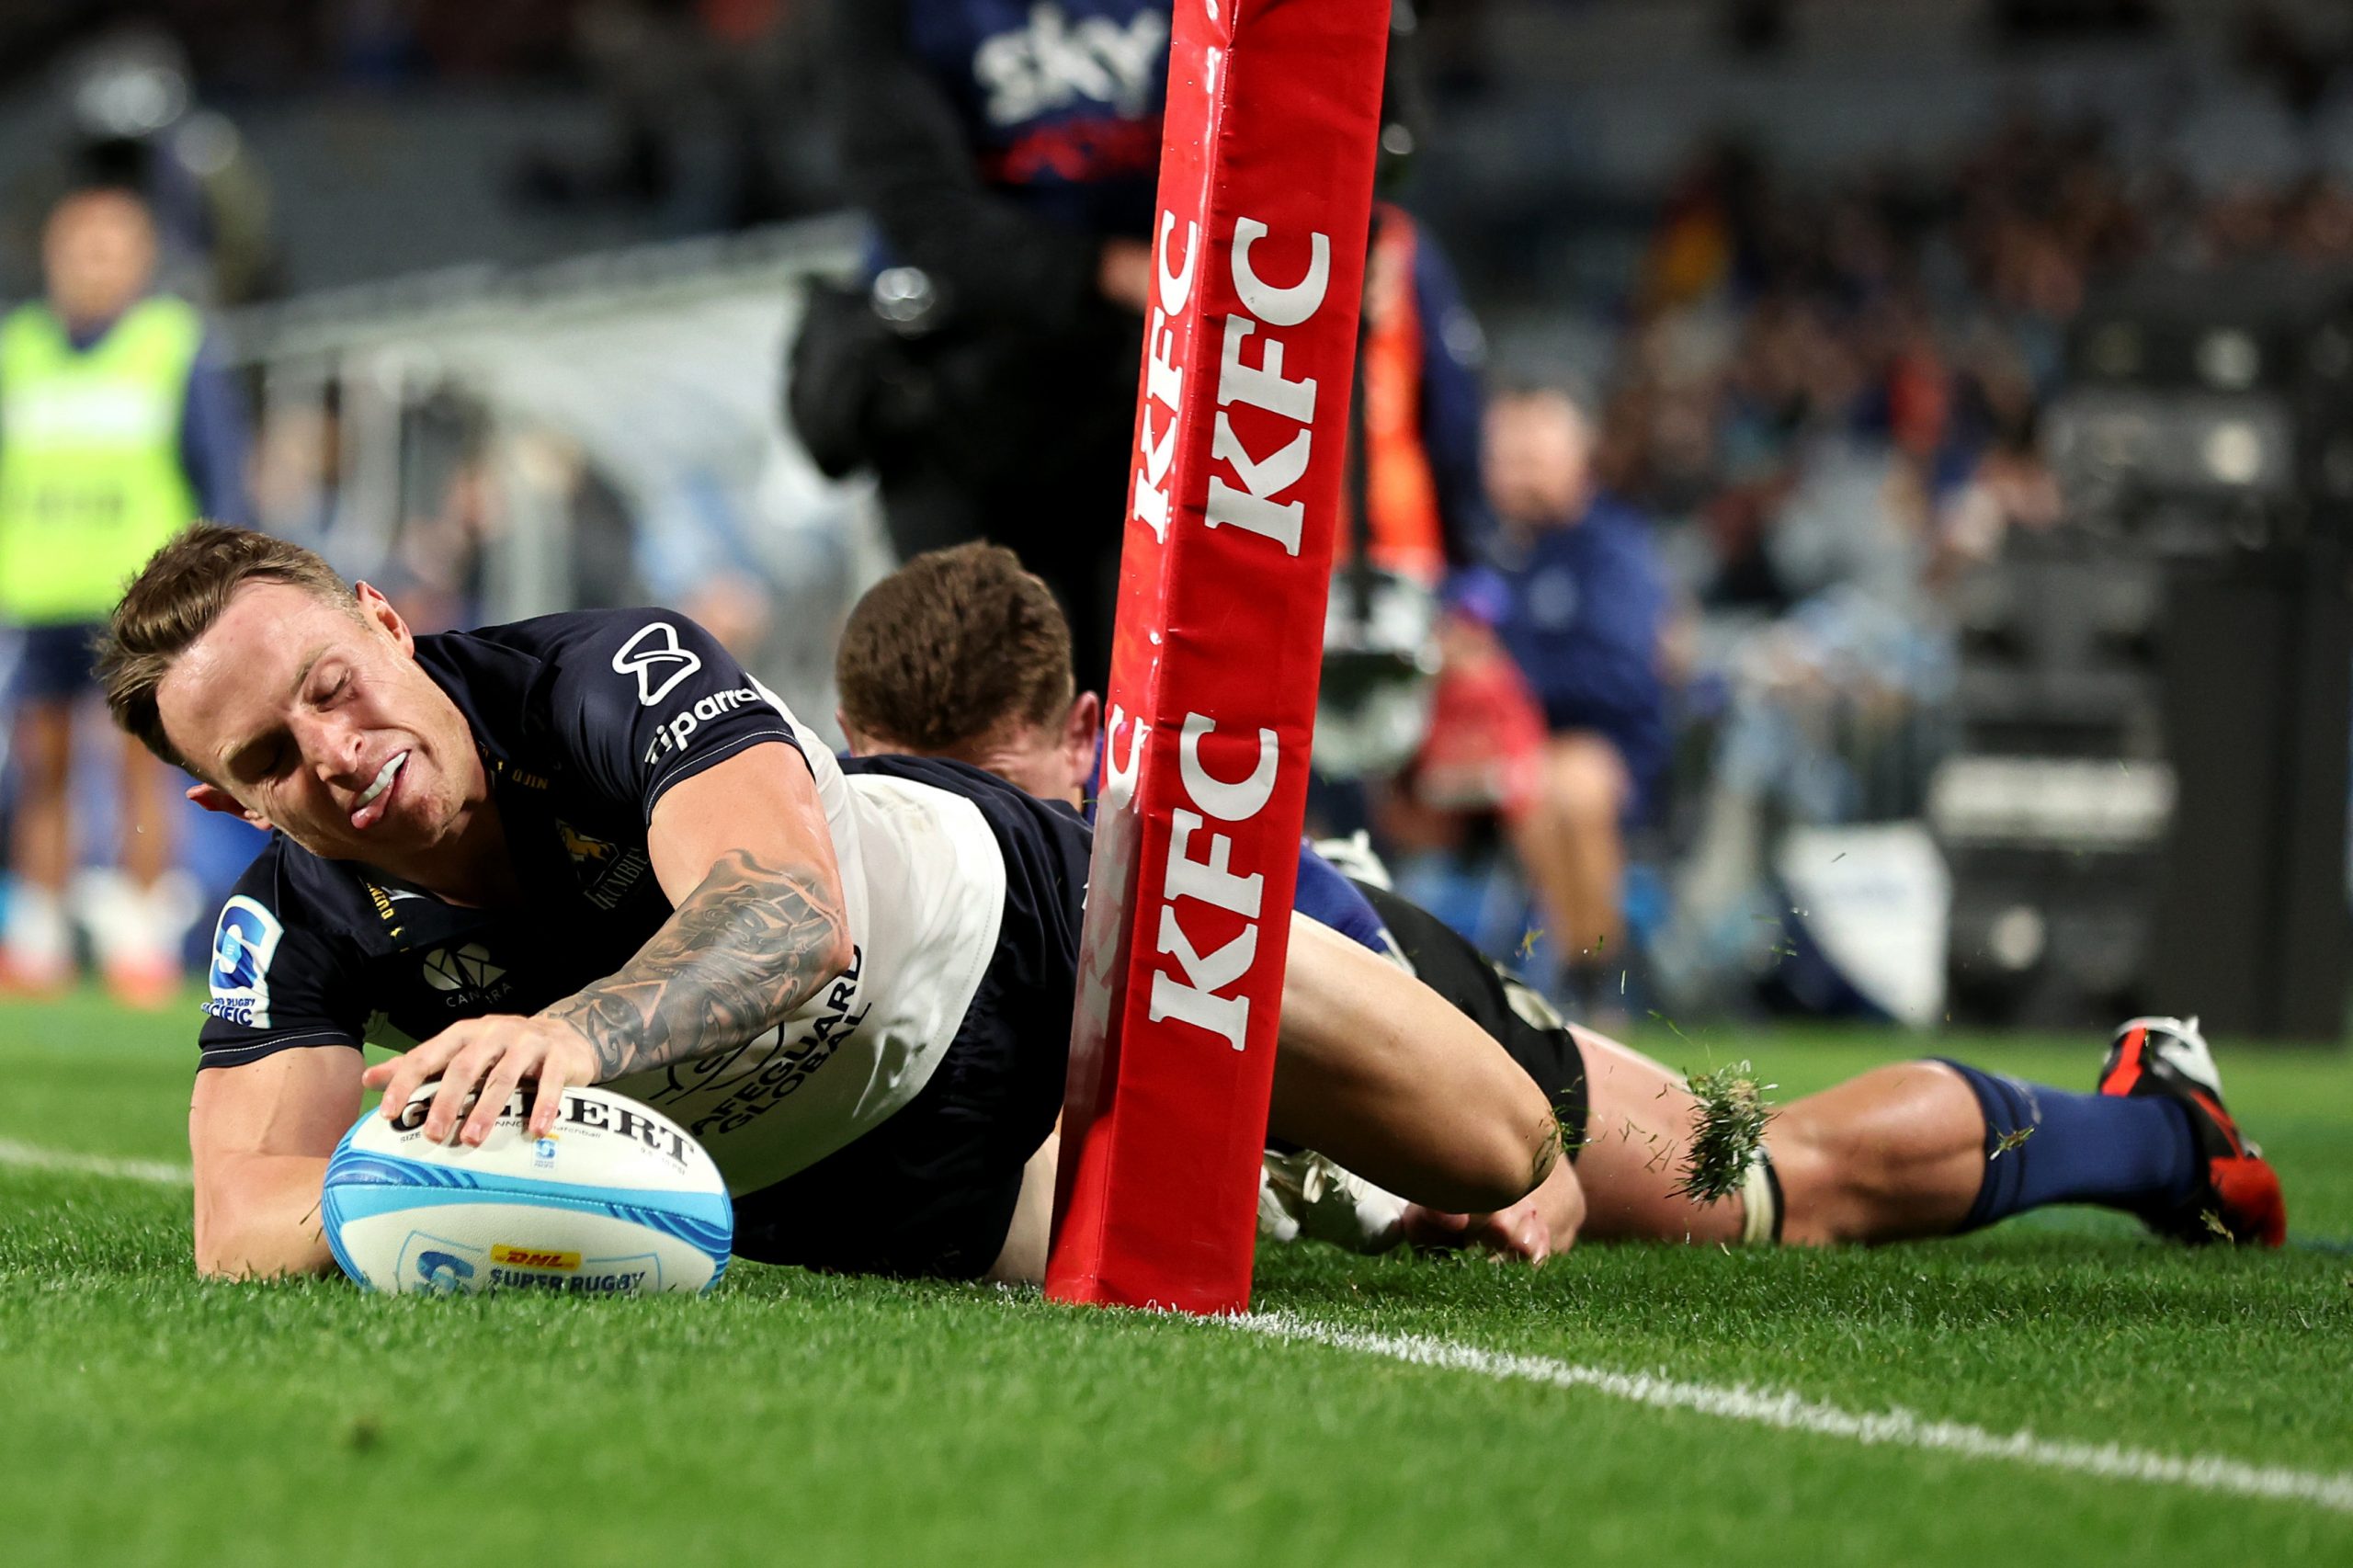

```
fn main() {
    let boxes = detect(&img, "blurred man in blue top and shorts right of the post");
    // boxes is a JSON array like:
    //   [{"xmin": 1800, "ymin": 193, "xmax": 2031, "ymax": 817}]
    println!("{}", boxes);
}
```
[{"xmin": 1487, "ymin": 389, "xmax": 1668, "ymax": 1006}]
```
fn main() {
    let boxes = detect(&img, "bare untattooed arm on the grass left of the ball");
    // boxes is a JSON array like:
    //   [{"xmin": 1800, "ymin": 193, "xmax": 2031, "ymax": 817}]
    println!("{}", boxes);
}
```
[{"xmin": 188, "ymin": 1045, "xmax": 360, "ymax": 1278}]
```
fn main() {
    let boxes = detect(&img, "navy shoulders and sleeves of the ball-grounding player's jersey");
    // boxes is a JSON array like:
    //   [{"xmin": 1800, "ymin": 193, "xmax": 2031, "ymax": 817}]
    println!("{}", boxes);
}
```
[{"xmin": 202, "ymin": 609, "xmax": 798, "ymax": 1066}]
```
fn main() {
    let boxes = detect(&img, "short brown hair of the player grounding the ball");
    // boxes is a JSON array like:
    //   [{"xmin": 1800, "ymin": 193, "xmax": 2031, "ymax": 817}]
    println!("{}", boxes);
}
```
[{"xmin": 97, "ymin": 523, "xmax": 360, "ymax": 772}]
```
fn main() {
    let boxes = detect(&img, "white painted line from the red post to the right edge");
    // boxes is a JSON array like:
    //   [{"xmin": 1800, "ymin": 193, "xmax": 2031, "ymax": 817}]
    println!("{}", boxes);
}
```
[{"xmin": 1219, "ymin": 1312, "xmax": 2353, "ymax": 1514}]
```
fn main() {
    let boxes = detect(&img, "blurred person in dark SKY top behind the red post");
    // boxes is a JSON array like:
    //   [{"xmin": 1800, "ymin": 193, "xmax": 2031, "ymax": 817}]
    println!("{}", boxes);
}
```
[{"xmin": 793, "ymin": 0, "xmax": 1169, "ymax": 685}]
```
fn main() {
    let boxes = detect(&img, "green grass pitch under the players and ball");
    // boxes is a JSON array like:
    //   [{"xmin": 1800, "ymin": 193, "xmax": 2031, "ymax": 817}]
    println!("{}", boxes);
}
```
[{"xmin": 0, "ymin": 1001, "xmax": 2353, "ymax": 1568}]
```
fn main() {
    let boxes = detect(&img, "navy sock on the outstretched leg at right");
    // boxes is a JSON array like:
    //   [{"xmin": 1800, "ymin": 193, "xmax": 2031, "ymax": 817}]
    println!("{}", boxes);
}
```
[{"xmin": 1937, "ymin": 1057, "xmax": 2198, "ymax": 1232}]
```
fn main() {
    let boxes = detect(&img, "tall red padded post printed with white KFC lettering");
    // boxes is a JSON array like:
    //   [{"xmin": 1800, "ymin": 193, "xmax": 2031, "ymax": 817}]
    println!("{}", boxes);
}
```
[{"xmin": 1047, "ymin": 0, "xmax": 1391, "ymax": 1312}]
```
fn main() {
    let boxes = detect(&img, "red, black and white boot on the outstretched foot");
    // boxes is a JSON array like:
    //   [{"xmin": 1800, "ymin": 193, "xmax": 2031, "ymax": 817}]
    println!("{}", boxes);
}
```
[{"xmin": 2099, "ymin": 1017, "xmax": 2287, "ymax": 1248}]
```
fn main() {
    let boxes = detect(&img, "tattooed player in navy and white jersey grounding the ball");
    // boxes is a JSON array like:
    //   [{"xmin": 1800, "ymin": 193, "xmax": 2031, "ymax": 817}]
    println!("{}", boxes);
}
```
[{"xmin": 101, "ymin": 528, "xmax": 1558, "ymax": 1278}]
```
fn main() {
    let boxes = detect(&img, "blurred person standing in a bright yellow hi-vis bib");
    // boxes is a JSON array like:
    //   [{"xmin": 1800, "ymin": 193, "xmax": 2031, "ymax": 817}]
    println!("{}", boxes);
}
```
[{"xmin": 0, "ymin": 188, "xmax": 244, "ymax": 1006}]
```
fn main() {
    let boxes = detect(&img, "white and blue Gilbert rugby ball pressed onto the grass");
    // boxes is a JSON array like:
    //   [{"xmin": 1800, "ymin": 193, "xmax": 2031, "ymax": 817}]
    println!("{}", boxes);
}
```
[{"xmin": 320, "ymin": 1083, "xmax": 734, "ymax": 1295}]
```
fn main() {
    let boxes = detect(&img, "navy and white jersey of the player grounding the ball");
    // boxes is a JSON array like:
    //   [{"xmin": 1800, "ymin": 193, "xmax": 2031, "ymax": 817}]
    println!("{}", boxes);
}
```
[{"xmin": 200, "ymin": 609, "xmax": 1087, "ymax": 1191}]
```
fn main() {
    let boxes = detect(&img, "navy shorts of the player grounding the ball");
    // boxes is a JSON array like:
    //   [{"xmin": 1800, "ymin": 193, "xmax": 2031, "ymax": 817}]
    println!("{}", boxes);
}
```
[{"xmin": 734, "ymin": 756, "xmax": 1089, "ymax": 1278}]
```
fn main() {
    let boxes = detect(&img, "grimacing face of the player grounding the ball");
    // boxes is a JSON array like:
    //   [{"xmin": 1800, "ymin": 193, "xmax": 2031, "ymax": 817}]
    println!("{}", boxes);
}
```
[{"xmin": 155, "ymin": 582, "xmax": 487, "ymax": 876}]
